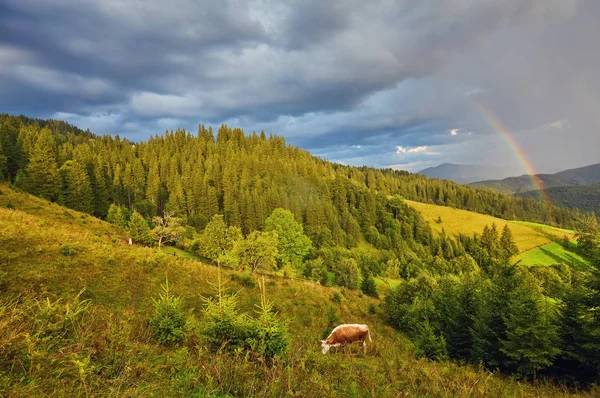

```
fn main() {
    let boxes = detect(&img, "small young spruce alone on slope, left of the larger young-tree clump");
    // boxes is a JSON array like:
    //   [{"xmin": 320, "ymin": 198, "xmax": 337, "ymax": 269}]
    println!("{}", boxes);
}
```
[{"xmin": 150, "ymin": 279, "xmax": 186, "ymax": 346}]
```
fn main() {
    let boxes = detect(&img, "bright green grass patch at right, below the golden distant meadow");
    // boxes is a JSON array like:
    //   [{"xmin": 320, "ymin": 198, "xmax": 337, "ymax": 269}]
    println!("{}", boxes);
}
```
[{"xmin": 515, "ymin": 241, "xmax": 590, "ymax": 270}]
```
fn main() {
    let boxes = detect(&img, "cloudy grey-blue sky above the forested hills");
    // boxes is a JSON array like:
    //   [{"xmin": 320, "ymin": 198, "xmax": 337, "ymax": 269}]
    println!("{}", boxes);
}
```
[{"xmin": 0, "ymin": 0, "xmax": 600, "ymax": 176}]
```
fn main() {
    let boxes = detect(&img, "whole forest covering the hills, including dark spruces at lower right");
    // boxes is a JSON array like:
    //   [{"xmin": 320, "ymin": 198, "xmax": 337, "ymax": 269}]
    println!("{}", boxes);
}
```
[{"xmin": 0, "ymin": 115, "xmax": 600, "ymax": 385}]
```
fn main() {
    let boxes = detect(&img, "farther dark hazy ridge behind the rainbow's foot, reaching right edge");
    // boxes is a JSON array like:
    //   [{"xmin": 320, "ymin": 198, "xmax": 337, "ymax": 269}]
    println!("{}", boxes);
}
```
[{"xmin": 469, "ymin": 163, "xmax": 600, "ymax": 193}]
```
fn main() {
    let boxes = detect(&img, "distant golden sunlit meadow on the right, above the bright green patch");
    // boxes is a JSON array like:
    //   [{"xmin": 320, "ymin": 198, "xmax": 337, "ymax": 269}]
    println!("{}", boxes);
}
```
[{"xmin": 407, "ymin": 201, "xmax": 573, "ymax": 252}]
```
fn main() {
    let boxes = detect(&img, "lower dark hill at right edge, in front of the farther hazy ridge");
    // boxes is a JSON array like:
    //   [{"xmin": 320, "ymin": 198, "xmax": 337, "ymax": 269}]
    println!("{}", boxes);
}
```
[{"xmin": 516, "ymin": 184, "xmax": 600, "ymax": 214}]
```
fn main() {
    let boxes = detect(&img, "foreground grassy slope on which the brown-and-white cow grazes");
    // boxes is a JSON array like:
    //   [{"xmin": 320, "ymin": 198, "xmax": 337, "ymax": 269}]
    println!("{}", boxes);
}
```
[{"xmin": 0, "ymin": 186, "xmax": 598, "ymax": 397}]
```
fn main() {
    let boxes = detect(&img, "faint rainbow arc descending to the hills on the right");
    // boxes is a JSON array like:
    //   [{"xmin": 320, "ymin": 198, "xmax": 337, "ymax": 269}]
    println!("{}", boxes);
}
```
[{"xmin": 469, "ymin": 95, "xmax": 551, "ymax": 205}]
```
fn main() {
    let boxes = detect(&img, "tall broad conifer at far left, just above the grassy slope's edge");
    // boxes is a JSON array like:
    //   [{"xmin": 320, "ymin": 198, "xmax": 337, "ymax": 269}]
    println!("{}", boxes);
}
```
[{"xmin": 24, "ymin": 127, "xmax": 60, "ymax": 201}]
